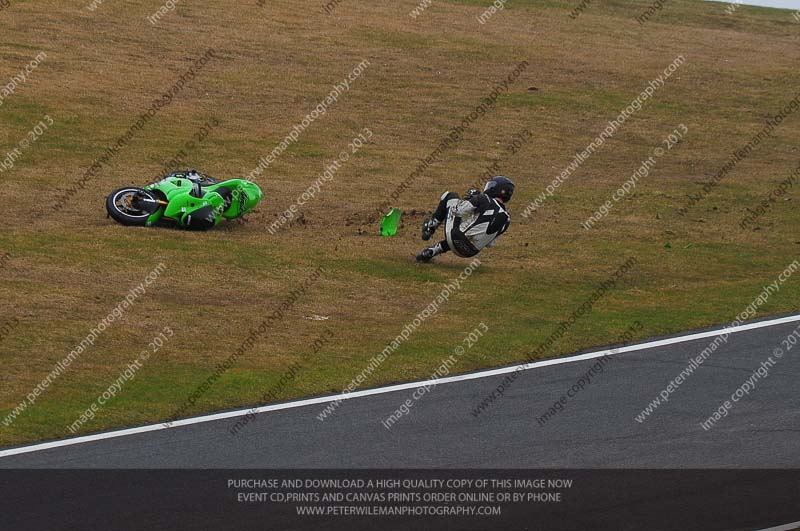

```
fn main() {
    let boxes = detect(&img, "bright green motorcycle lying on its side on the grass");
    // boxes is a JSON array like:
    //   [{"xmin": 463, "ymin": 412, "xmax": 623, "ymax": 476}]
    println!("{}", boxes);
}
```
[{"xmin": 106, "ymin": 170, "xmax": 263, "ymax": 230}]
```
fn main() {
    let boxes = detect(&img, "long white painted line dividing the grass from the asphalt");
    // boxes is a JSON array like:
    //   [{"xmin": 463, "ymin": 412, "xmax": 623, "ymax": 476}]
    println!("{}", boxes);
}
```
[{"xmin": 0, "ymin": 314, "xmax": 800, "ymax": 458}]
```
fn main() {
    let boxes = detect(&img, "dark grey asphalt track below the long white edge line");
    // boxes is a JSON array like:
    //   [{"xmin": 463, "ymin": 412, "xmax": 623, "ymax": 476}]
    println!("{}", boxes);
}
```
[{"xmin": 0, "ymin": 316, "xmax": 800, "ymax": 469}]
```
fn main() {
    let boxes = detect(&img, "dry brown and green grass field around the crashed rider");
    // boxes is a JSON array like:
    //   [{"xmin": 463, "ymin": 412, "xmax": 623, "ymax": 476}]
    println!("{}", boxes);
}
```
[{"xmin": 0, "ymin": 0, "xmax": 800, "ymax": 444}]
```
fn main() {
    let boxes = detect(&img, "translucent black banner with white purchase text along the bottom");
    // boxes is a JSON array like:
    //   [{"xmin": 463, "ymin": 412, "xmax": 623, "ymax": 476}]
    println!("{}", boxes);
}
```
[{"xmin": 0, "ymin": 470, "xmax": 800, "ymax": 531}]
